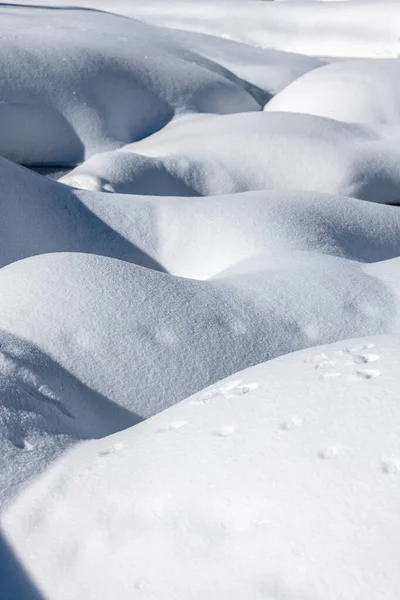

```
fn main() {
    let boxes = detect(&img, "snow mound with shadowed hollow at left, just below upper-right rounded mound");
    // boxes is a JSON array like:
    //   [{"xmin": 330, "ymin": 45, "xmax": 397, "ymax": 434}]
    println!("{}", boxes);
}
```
[{"xmin": 60, "ymin": 111, "xmax": 400, "ymax": 204}]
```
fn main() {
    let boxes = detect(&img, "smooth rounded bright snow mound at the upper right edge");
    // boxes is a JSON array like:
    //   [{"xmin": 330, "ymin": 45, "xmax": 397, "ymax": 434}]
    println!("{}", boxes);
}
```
[{"xmin": 265, "ymin": 59, "xmax": 400, "ymax": 128}]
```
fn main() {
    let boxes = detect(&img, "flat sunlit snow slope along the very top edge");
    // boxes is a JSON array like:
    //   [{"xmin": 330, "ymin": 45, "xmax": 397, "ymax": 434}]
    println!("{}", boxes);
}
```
[{"xmin": 7, "ymin": 0, "xmax": 400, "ymax": 58}]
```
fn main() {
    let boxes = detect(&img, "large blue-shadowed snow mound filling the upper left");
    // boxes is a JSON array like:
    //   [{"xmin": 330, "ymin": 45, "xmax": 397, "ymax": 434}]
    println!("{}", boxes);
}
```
[{"xmin": 0, "ymin": 6, "xmax": 260, "ymax": 165}]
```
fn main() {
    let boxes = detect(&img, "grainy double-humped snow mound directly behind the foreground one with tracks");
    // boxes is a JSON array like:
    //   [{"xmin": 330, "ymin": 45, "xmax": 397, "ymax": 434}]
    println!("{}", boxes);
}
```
[{"xmin": 0, "ymin": 251, "xmax": 400, "ymax": 503}]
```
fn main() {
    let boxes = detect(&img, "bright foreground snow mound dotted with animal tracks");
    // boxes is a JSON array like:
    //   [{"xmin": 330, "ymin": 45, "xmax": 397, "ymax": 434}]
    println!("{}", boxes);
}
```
[{"xmin": 3, "ymin": 336, "xmax": 400, "ymax": 600}]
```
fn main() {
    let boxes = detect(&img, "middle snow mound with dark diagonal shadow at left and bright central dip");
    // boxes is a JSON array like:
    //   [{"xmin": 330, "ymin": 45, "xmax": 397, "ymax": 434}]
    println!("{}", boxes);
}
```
[{"xmin": 0, "ymin": 158, "xmax": 400, "ymax": 279}]
